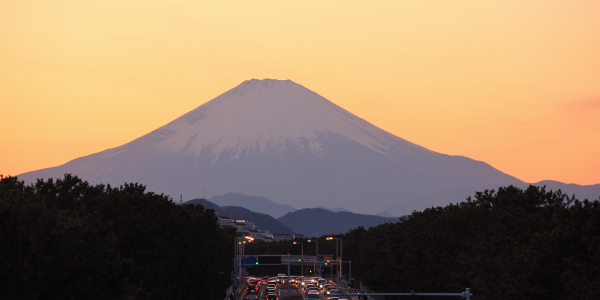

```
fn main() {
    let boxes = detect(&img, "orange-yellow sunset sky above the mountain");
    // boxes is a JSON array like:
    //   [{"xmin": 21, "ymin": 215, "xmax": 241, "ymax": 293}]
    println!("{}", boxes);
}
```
[{"xmin": 0, "ymin": 0, "xmax": 600, "ymax": 184}]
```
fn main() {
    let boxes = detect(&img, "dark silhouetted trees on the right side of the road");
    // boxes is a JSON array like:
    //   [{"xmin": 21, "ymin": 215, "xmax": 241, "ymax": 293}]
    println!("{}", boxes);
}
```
[{"xmin": 246, "ymin": 186, "xmax": 600, "ymax": 300}]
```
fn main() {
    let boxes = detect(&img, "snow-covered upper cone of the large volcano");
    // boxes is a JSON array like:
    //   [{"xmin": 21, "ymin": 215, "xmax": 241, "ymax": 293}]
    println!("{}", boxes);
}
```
[{"xmin": 125, "ymin": 79, "xmax": 423, "ymax": 159}]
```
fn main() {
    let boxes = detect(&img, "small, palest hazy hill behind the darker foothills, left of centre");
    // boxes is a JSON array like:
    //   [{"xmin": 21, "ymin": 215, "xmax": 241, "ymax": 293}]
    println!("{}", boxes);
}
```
[{"xmin": 210, "ymin": 193, "xmax": 296, "ymax": 218}]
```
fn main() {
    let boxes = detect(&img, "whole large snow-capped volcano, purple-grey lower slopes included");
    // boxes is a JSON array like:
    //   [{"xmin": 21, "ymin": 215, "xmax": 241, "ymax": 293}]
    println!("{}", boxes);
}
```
[{"xmin": 19, "ymin": 79, "xmax": 600, "ymax": 215}]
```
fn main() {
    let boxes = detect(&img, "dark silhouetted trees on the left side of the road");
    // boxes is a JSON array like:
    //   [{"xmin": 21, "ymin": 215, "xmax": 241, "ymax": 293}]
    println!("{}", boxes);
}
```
[{"xmin": 0, "ymin": 174, "xmax": 235, "ymax": 299}]
